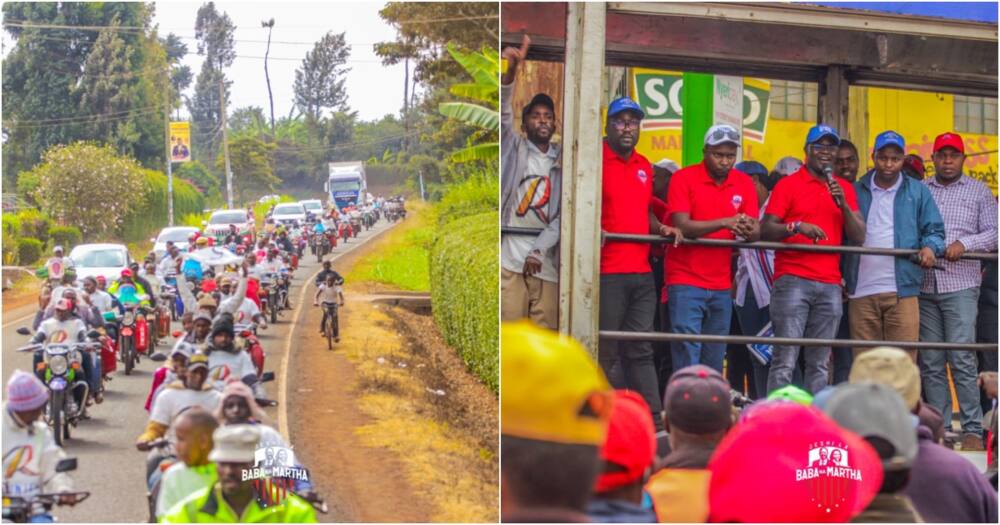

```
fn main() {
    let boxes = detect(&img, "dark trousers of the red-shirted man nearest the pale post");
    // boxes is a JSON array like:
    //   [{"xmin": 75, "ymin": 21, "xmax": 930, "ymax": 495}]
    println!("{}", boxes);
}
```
[{"xmin": 598, "ymin": 273, "xmax": 663, "ymax": 430}]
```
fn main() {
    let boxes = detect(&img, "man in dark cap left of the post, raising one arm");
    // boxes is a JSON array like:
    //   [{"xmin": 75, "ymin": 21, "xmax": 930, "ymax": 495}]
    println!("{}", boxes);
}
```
[{"xmin": 500, "ymin": 35, "xmax": 562, "ymax": 330}]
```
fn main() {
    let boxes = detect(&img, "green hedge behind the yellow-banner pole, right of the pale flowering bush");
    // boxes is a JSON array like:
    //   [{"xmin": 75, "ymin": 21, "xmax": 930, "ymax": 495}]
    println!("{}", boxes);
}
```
[{"xmin": 120, "ymin": 170, "xmax": 205, "ymax": 241}]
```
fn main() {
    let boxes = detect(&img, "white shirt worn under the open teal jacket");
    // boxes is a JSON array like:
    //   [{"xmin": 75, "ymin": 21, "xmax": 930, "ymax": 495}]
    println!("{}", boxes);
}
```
[{"xmin": 851, "ymin": 173, "xmax": 906, "ymax": 299}]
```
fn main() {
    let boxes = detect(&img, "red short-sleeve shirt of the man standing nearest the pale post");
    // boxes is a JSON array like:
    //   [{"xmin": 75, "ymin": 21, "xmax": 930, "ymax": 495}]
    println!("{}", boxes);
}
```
[{"xmin": 601, "ymin": 141, "xmax": 653, "ymax": 274}]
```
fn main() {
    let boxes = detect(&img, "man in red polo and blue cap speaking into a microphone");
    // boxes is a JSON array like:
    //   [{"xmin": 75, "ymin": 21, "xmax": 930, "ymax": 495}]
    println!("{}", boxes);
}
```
[{"xmin": 761, "ymin": 125, "xmax": 865, "ymax": 394}]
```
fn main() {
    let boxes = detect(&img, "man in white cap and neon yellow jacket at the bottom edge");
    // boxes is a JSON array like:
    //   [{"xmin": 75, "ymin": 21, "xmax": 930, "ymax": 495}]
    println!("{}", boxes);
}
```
[{"xmin": 161, "ymin": 425, "xmax": 316, "ymax": 523}]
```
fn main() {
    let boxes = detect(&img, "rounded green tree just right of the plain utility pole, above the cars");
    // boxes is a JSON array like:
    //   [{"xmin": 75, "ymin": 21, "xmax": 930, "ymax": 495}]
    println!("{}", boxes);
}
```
[{"xmin": 215, "ymin": 137, "xmax": 281, "ymax": 202}]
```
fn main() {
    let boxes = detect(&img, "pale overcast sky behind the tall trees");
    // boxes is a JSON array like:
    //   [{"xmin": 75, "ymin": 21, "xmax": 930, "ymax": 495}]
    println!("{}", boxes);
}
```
[{"xmin": 2, "ymin": 0, "xmax": 412, "ymax": 120}]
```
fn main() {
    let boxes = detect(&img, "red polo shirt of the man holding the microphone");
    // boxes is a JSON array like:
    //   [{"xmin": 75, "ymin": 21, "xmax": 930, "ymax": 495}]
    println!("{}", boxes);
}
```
[{"xmin": 764, "ymin": 165, "xmax": 858, "ymax": 284}]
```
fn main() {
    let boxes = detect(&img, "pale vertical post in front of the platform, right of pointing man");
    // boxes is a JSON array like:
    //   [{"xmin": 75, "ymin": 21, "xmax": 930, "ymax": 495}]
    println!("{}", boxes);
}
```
[{"xmin": 559, "ymin": 2, "xmax": 607, "ymax": 358}]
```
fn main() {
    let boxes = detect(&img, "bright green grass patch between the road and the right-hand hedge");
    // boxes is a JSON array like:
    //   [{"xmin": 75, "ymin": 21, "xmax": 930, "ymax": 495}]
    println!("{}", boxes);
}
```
[{"xmin": 345, "ymin": 201, "xmax": 434, "ymax": 292}]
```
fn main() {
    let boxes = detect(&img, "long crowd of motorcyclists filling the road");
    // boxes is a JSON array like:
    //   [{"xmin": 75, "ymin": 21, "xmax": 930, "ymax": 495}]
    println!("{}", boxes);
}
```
[{"xmin": 3, "ymin": 198, "xmax": 405, "ymax": 522}]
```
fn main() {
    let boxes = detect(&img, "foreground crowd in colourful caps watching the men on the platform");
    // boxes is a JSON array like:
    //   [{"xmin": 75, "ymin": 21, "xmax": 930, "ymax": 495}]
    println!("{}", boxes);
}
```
[{"xmin": 500, "ymin": 320, "xmax": 997, "ymax": 523}]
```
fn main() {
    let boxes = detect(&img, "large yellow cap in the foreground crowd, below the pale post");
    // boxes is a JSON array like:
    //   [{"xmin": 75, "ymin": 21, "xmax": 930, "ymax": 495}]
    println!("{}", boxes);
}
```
[{"xmin": 500, "ymin": 321, "xmax": 614, "ymax": 446}]
